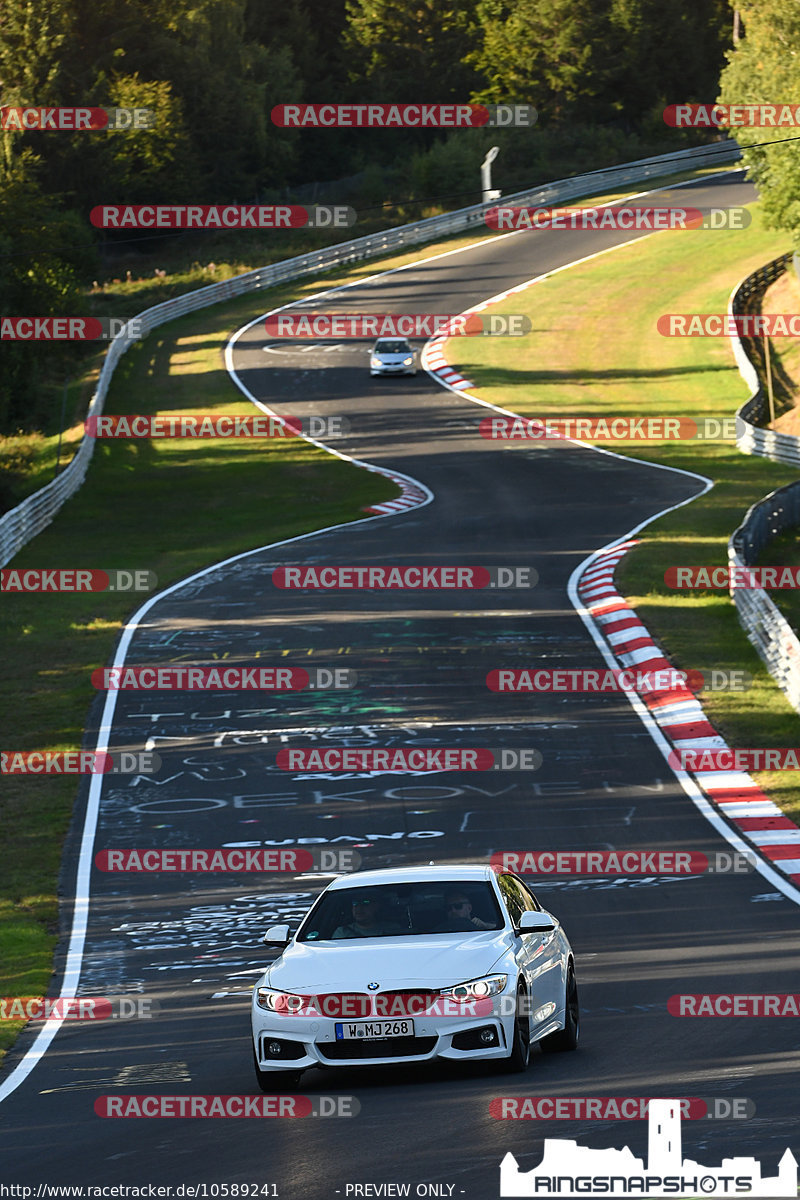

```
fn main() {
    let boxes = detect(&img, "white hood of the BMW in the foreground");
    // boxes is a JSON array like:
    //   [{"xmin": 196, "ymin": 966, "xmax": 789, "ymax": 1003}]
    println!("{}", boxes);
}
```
[{"xmin": 265, "ymin": 930, "xmax": 511, "ymax": 992}]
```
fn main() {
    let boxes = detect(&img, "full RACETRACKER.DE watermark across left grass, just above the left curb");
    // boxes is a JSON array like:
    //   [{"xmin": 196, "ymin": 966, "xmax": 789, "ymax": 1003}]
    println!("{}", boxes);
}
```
[{"xmin": 84, "ymin": 413, "xmax": 350, "ymax": 442}]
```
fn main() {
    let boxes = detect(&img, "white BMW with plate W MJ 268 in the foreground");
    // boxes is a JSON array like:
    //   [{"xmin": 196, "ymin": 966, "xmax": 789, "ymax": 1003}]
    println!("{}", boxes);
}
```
[{"xmin": 252, "ymin": 865, "xmax": 579, "ymax": 1092}]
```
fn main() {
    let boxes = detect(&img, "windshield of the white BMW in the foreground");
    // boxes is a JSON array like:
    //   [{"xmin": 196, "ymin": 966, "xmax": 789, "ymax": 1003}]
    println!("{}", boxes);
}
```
[{"xmin": 297, "ymin": 881, "xmax": 504, "ymax": 942}]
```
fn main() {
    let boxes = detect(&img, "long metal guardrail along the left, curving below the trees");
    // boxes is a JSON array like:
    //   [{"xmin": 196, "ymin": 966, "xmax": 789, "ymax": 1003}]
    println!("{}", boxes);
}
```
[{"xmin": 0, "ymin": 142, "xmax": 741, "ymax": 566}]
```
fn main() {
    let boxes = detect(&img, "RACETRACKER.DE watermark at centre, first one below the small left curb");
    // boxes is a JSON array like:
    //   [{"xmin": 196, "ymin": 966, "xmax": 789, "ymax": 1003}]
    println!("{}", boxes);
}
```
[{"xmin": 272, "ymin": 563, "xmax": 539, "ymax": 592}]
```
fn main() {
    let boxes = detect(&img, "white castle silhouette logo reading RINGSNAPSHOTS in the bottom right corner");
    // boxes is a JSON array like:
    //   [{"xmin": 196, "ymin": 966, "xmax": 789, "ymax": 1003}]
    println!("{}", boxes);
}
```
[{"xmin": 500, "ymin": 1099, "xmax": 798, "ymax": 1200}]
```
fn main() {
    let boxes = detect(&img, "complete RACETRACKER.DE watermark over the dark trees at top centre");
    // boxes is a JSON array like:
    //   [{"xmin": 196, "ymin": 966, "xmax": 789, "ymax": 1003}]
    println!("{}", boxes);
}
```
[{"xmin": 270, "ymin": 102, "xmax": 537, "ymax": 130}]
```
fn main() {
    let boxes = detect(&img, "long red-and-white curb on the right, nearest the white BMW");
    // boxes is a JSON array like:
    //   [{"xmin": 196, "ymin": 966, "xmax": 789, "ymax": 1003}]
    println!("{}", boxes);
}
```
[{"xmin": 578, "ymin": 540, "xmax": 800, "ymax": 886}]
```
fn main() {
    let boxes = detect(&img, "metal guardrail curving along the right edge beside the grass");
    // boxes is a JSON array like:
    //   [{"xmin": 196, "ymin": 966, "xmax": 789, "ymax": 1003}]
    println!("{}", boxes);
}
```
[{"xmin": 728, "ymin": 253, "xmax": 800, "ymax": 712}]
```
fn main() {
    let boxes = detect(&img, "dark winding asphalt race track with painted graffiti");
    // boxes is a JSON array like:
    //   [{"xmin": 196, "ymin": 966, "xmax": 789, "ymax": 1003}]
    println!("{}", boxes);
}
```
[{"xmin": 0, "ymin": 175, "xmax": 800, "ymax": 1200}]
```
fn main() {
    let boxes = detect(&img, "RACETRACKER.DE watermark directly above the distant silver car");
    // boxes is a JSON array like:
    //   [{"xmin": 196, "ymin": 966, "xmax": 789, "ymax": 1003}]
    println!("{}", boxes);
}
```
[{"xmin": 264, "ymin": 312, "xmax": 533, "ymax": 341}]
